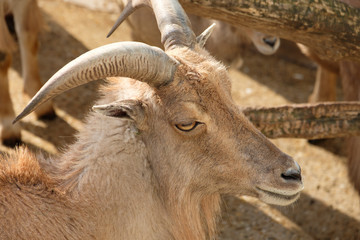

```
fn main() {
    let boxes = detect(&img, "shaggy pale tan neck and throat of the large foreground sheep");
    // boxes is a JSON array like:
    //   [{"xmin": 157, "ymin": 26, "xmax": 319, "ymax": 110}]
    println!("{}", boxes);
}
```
[{"xmin": 44, "ymin": 107, "xmax": 220, "ymax": 239}]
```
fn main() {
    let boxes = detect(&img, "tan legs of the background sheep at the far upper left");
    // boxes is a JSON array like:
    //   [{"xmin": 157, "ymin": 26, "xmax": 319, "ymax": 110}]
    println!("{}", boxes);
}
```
[{"xmin": 0, "ymin": 0, "xmax": 54, "ymax": 145}]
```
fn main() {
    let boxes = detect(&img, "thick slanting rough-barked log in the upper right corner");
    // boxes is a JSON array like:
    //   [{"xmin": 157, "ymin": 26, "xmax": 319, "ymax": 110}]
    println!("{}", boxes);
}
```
[{"xmin": 180, "ymin": 0, "xmax": 360, "ymax": 61}]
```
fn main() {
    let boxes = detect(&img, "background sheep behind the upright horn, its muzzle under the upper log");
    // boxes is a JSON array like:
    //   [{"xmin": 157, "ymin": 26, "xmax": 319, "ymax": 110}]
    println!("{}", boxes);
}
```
[{"xmin": 108, "ymin": 0, "xmax": 280, "ymax": 67}]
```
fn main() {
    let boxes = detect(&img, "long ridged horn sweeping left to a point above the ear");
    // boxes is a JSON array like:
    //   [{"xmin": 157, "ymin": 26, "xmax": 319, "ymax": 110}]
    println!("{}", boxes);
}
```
[{"xmin": 14, "ymin": 42, "xmax": 178, "ymax": 123}]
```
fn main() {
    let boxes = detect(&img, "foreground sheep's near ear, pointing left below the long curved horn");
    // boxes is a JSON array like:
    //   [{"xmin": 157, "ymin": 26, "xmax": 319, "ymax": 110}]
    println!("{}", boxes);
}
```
[{"xmin": 92, "ymin": 100, "xmax": 145, "ymax": 122}]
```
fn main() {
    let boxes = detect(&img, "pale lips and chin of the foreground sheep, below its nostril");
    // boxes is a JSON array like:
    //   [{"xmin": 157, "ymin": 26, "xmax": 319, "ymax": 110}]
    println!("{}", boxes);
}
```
[{"xmin": 256, "ymin": 187, "xmax": 300, "ymax": 206}]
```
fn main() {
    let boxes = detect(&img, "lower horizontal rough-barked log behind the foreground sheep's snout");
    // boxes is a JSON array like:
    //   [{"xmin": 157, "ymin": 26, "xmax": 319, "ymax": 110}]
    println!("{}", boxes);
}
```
[{"xmin": 243, "ymin": 102, "xmax": 360, "ymax": 139}]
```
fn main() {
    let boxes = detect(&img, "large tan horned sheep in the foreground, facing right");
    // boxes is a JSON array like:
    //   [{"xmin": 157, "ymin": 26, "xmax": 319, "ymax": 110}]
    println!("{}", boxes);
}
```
[{"xmin": 4, "ymin": 0, "xmax": 303, "ymax": 240}]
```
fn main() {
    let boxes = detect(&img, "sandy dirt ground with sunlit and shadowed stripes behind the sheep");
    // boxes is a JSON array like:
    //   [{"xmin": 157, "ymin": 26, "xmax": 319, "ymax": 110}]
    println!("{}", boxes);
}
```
[{"xmin": 0, "ymin": 0, "xmax": 360, "ymax": 240}]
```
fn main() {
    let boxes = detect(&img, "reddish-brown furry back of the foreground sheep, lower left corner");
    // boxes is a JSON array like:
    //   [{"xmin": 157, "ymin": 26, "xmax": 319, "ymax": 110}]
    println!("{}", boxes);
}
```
[{"xmin": 0, "ymin": 149, "xmax": 95, "ymax": 239}]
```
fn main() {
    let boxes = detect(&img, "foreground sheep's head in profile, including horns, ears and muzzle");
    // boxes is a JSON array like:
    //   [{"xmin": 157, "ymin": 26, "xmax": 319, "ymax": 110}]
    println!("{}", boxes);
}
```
[{"xmin": 16, "ymin": 1, "xmax": 303, "ymax": 205}]
